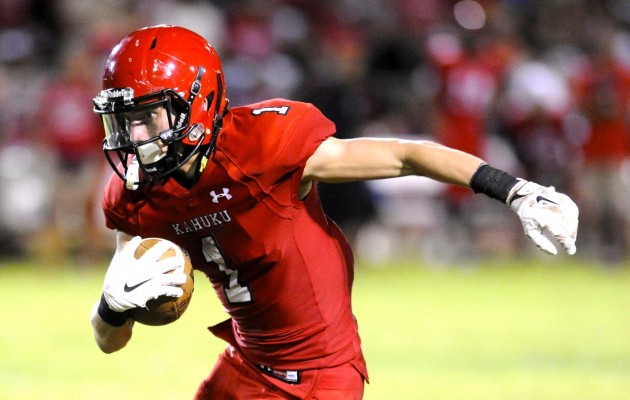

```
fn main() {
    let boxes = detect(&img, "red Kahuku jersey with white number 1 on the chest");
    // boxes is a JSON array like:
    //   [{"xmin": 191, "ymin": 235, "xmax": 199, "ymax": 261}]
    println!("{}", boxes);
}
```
[{"xmin": 103, "ymin": 99, "xmax": 366, "ymax": 375}]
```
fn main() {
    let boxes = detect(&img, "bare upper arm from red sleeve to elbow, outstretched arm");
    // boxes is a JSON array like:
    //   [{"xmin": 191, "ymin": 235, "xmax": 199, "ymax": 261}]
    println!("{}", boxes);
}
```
[{"xmin": 303, "ymin": 137, "xmax": 410, "ymax": 183}]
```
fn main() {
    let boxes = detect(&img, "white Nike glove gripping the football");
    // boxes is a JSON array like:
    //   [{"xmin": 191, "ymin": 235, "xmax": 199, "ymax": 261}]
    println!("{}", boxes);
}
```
[{"xmin": 103, "ymin": 236, "xmax": 186, "ymax": 312}]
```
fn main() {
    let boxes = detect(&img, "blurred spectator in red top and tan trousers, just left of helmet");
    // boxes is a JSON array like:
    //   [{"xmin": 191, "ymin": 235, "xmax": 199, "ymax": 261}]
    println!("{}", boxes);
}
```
[{"xmin": 31, "ymin": 43, "xmax": 111, "ymax": 261}]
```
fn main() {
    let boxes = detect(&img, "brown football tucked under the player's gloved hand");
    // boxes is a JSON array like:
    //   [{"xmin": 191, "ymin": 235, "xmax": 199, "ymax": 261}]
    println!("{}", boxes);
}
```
[{"xmin": 130, "ymin": 238, "xmax": 195, "ymax": 326}]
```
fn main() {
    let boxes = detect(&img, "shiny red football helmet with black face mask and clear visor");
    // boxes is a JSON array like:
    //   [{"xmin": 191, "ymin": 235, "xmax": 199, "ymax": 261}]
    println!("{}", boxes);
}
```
[{"xmin": 94, "ymin": 25, "xmax": 228, "ymax": 188}]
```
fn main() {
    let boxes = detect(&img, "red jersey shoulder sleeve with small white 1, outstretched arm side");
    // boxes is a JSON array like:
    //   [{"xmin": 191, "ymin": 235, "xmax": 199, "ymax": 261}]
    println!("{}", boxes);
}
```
[{"xmin": 218, "ymin": 99, "xmax": 336, "ymax": 204}]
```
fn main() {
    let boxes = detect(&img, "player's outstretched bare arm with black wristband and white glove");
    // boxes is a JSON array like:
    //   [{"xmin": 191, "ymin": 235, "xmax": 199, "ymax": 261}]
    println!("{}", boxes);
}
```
[{"xmin": 302, "ymin": 137, "xmax": 579, "ymax": 254}]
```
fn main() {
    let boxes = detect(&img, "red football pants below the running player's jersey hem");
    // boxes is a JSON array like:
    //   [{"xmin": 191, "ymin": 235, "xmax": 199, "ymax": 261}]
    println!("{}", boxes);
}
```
[{"xmin": 195, "ymin": 345, "xmax": 364, "ymax": 400}]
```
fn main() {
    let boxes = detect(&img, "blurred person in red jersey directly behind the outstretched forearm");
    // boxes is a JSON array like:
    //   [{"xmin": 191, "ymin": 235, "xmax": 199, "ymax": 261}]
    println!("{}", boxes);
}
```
[{"xmin": 427, "ymin": 30, "xmax": 500, "ymax": 258}]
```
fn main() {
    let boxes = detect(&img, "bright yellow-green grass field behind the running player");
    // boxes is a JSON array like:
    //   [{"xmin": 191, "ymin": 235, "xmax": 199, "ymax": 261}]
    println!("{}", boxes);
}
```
[{"xmin": 0, "ymin": 258, "xmax": 630, "ymax": 400}]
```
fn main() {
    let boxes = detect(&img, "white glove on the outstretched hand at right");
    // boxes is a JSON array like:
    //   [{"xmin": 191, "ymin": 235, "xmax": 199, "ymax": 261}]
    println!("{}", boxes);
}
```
[{"xmin": 507, "ymin": 179, "xmax": 579, "ymax": 255}]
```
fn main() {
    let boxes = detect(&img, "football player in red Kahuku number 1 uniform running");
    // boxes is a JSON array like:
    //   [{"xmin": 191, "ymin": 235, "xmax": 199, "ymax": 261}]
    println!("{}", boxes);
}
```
[{"xmin": 91, "ymin": 26, "xmax": 578, "ymax": 399}]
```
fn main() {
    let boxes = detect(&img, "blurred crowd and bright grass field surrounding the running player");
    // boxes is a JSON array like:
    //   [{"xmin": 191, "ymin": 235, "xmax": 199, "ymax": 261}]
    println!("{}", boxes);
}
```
[{"xmin": 0, "ymin": 0, "xmax": 630, "ymax": 400}]
